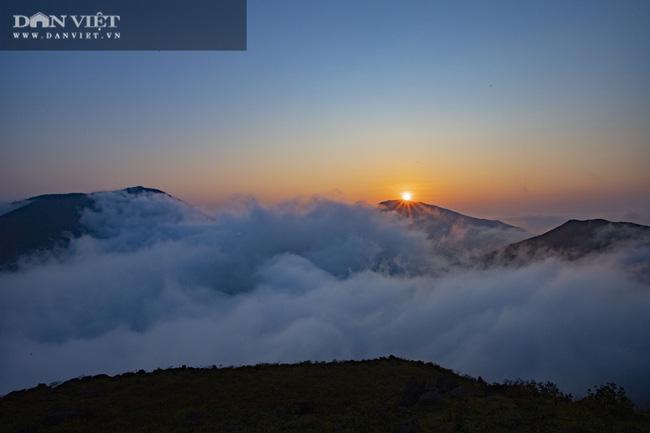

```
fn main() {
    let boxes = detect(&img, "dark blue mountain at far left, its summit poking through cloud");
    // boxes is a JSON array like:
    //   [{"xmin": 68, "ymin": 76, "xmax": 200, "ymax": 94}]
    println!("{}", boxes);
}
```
[{"xmin": 0, "ymin": 186, "xmax": 168, "ymax": 269}]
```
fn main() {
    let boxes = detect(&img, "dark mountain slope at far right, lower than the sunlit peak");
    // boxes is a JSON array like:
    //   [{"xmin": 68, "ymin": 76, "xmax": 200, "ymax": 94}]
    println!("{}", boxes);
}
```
[{"xmin": 486, "ymin": 219, "xmax": 650, "ymax": 265}]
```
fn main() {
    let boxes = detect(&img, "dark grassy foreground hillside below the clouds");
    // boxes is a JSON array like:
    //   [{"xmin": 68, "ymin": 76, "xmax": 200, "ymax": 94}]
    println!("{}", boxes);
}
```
[{"xmin": 0, "ymin": 357, "xmax": 650, "ymax": 433}]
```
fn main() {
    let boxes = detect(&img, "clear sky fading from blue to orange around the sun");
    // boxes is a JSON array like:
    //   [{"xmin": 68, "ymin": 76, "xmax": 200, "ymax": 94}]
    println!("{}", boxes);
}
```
[{"xmin": 0, "ymin": 0, "xmax": 650, "ymax": 223}]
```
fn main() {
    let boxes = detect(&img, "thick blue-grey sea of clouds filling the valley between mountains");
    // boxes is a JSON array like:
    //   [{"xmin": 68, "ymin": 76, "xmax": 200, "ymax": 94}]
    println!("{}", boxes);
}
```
[{"xmin": 0, "ymin": 193, "xmax": 650, "ymax": 404}]
